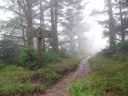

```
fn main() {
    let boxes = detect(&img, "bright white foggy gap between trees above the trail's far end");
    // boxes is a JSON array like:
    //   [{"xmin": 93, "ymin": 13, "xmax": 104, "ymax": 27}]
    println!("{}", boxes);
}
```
[{"xmin": 83, "ymin": 0, "xmax": 108, "ymax": 51}]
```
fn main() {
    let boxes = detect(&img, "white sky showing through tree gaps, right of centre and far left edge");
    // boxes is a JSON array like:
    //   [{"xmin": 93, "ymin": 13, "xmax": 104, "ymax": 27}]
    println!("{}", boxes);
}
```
[{"xmin": 0, "ymin": 0, "xmax": 107, "ymax": 49}]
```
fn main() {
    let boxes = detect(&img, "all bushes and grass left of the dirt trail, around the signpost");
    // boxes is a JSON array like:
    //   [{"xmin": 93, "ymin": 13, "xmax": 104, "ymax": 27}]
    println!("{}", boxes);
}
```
[{"xmin": 0, "ymin": 39, "xmax": 86, "ymax": 96}]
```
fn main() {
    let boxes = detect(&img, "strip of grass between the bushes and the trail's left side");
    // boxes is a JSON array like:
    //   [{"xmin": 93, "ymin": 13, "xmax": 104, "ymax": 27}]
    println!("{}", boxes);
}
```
[{"xmin": 0, "ymin": 59, "xmax": 79, "ymax": 96}]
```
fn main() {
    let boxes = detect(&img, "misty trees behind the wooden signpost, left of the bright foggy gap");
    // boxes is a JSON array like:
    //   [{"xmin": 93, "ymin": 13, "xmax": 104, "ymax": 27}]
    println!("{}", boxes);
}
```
[{"xmin": 0, "ymin": 0, "xmax": 89, "ymax": 52}]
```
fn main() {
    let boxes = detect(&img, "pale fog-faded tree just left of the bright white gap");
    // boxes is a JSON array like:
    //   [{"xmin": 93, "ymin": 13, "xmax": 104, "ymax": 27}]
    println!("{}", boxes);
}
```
[{"xmin": 61, "ymin": 0, "xmax": 87, "ymax": 53}]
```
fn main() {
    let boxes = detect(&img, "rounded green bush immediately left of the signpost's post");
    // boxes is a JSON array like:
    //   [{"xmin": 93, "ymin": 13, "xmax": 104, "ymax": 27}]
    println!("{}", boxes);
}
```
[{"xmin": 19, "ymin": 47, "xmax": 37, "ymax": 70}]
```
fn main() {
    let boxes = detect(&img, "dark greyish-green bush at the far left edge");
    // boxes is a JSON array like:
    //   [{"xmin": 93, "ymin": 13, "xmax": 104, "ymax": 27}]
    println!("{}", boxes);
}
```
[{"xmin": 0, "ymin": 39, "xmax": 19, "ymax": 64}]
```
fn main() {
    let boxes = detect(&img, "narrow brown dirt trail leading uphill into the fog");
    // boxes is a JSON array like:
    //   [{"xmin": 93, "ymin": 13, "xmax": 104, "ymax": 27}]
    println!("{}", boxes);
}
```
[{"xmin": 40, "ymin": 57, "xmax": 91, "ymax": 96}]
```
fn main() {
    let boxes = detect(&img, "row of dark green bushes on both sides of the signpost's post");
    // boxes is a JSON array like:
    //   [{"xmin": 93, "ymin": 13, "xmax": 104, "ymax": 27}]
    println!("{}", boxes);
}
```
[{"xmin": 0, "ymin": 39, "xmax": 62, "ymax": 70}]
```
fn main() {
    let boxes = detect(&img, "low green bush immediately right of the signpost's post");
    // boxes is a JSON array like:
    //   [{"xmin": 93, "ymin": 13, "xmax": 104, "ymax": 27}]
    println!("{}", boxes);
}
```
[{"xmin": 43, "ymin": 51, "xmax": 61, "ymax": 65}]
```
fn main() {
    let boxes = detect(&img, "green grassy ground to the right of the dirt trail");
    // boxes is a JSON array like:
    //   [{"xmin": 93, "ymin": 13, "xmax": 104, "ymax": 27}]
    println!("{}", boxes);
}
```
[{"xmin": 69, "ymin": 56, "xmax": 128, "ymax": 96}]
